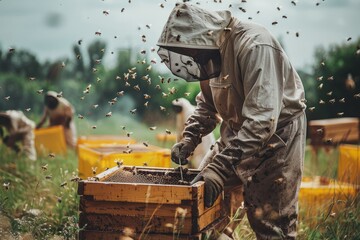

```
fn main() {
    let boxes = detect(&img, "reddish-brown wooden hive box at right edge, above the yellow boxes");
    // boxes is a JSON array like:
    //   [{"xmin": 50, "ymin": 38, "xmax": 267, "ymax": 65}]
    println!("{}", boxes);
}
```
[{"xmin": 309, "ymin": 118, "xmax": 359, "ymax": 145}]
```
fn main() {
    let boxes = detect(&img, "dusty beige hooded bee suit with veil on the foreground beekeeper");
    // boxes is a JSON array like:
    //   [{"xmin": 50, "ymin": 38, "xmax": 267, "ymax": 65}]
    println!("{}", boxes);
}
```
[{"xmin": 158, "ymin": 4, "xmax": 306, "ymax": 239}]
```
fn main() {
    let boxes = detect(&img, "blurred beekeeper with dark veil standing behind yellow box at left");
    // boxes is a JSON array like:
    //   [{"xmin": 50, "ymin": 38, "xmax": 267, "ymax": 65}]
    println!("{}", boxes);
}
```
[{"xmin": 36, "ymin": 91, "xmax": 76, "ymax": 148}]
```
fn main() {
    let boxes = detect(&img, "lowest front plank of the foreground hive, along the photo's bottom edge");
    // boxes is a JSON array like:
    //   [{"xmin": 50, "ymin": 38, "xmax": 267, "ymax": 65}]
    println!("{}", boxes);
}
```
[{"xmin": 79, "ymin": 230, "xmax": 201, "ymax": 240}]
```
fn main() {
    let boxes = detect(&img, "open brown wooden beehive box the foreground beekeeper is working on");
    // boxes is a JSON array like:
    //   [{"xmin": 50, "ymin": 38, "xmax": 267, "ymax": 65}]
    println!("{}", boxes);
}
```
[{"xmin": 78, "ymin": 166, "xmax": 222, "ymax": 239}]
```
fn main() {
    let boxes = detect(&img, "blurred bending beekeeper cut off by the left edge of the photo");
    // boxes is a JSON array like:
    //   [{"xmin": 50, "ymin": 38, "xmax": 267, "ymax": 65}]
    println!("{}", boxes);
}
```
[{"xmin": 0, "ymin": 110, "xmax": 36, "ymax": 160}]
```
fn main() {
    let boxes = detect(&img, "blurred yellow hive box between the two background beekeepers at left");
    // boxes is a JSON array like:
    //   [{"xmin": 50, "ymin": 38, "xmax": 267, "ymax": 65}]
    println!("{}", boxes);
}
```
[{"xmin": 34, "ymin": 125, "xmax": 66, "ymax": 156}]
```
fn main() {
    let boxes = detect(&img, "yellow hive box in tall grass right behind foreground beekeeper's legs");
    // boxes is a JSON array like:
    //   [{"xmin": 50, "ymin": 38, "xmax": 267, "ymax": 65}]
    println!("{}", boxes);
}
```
[{"xmin": 299, "ymin": 177, "xmax": 358, "ymax": 224}]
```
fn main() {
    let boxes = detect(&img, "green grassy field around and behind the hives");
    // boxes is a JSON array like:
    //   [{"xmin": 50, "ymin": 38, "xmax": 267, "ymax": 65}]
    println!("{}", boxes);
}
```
[{"xmin": 0, "ymin": 118, "xmax": 360, "ymax": 240}]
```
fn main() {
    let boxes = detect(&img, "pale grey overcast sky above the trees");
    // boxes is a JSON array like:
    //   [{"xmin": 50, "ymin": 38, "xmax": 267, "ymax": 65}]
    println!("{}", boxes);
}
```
[{"xmin": 0, "ymin": 0, "xmax": 360, "ymax": 71}]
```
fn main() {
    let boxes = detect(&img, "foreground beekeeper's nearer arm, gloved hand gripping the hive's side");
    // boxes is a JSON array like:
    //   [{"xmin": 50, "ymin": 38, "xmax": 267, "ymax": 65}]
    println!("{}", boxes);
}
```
[{"xmin": 192, "ymin": 45, "xmax": 289, "ymax": 207}]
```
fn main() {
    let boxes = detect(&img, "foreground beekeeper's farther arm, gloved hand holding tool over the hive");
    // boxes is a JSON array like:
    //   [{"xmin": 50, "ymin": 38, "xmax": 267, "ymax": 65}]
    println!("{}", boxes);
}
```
[{"xmin": 171, "ymin": 81, "xmax": 218, "ymax": 165}]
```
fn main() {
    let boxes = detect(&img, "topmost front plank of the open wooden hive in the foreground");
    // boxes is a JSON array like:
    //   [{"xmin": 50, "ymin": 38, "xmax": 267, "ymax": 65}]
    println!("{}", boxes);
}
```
[{"xmin": 78, "ymin": 181, "xmax": 197, "ymax": 204}]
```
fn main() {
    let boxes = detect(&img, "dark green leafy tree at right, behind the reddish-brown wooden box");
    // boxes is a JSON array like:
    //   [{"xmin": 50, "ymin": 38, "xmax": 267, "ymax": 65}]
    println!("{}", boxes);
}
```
[{"xmin": 303, "ymin": 39, "xmax": 360, "ymax": 119}]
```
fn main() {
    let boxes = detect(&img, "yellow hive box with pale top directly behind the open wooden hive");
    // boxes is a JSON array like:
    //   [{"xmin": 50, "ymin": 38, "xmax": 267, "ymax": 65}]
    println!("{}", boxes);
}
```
[{"xmin": 78, "ymin": 144, "xmax": 171, "ymax": 178}]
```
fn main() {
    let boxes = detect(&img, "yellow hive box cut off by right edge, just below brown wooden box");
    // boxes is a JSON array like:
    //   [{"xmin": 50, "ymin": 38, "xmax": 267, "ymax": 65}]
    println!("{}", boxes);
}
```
[{"xmin": 338, "ymin": 144, "xmax": 360, "ymax": 185}]
